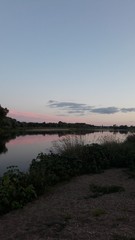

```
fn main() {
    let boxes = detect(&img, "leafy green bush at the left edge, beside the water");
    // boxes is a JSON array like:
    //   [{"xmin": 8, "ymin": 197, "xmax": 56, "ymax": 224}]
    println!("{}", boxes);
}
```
[{"xmin": 0, "ymin": 166, "xmax": 36, "ymax": 214}]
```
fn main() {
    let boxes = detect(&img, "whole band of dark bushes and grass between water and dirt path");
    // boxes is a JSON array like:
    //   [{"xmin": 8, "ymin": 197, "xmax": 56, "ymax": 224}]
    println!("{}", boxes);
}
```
[{"xmin": 0, "ymin": 135, "xmax": 135, "ymax": 214}]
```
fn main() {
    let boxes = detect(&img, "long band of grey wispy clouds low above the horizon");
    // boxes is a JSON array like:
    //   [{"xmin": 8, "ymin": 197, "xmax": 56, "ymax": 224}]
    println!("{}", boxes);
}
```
[{"xmin": 48, "ymin": 100, "xmax": 135, "ymax": 116}]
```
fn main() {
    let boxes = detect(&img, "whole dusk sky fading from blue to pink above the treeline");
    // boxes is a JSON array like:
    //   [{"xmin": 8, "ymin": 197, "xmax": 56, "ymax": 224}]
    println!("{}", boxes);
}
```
[{"xmin": 0, "ymin": 0, "xmax": 135, "ymax": 126}]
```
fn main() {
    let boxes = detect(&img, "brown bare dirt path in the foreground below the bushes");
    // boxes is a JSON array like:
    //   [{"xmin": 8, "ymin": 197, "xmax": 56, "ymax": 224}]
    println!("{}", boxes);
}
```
[{"xmin": 0, "ymin": 169, "xmax": 135, "ymax": 240}]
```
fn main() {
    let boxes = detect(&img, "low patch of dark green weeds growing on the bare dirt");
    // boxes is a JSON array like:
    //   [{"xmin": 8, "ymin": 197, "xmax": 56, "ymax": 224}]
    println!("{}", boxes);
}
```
[{"xmin": 90, "ymin": 184, "xmax": 125, "ymax": 198}]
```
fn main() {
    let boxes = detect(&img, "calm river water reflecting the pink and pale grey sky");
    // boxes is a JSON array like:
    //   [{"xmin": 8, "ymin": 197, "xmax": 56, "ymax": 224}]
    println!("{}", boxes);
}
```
[{"xmin": 0, "ymin": 132, "xmax": 127, "ymax": 175}]
